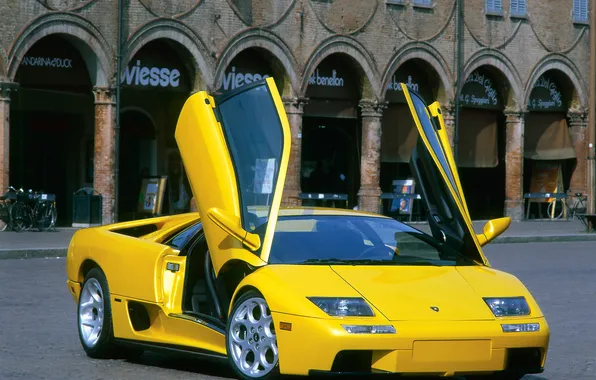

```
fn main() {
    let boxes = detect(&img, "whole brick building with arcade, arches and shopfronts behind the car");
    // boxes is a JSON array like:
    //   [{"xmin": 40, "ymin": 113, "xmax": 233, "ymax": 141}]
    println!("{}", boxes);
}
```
[{"xmin": 0, "ymin": 0, "xmax": 593, "ymax": 223}]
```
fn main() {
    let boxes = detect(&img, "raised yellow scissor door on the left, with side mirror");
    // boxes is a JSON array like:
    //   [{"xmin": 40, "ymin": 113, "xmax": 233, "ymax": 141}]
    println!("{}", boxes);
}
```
[{"xmin": 175, "ymin": 78, "xmax": 290, "ymax": 275}]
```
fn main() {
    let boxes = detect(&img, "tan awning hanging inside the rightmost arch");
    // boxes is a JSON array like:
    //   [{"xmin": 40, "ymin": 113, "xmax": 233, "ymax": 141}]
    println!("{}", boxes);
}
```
[{"xmin": 524, "ymin": 112, "xmax": 576, "ymax": 160}]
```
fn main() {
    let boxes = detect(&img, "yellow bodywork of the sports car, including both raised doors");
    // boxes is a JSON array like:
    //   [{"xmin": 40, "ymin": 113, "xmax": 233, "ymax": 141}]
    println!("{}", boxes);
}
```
[{"xmin": 66, "ymin": 78, "xmax": 550, "ymax": 376}]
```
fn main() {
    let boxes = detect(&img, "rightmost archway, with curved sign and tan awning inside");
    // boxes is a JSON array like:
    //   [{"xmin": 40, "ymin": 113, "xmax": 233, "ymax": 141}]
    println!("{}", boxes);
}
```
[{"xmin": 524, "ymin": 68, "xmax": 588, "ymax": 217}]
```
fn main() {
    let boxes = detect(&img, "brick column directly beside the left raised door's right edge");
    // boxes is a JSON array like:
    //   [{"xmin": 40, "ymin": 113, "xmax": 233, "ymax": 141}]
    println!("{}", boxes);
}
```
[{"xmin": 282, "ymin": 98, "xmax": 307, "ymax": 206}]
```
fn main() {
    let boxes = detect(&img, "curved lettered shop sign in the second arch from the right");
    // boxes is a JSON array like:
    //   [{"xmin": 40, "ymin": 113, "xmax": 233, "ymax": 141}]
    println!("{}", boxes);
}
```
[{"xmin": 459, "ymin": 71, "xmax": 501, "ymax": 109}]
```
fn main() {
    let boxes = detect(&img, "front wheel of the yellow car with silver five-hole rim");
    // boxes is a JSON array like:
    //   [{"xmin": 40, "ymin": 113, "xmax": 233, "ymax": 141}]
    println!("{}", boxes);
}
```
[{"xmin": 226, "ymin": 290, "xmax": 279, "ymax": 380}]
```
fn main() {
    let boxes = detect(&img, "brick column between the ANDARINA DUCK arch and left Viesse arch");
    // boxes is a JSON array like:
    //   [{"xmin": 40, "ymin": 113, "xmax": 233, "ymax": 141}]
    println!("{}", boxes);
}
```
[{"xmin": 93, "ymin": 87, "xmax": 117, "ymax": 224}]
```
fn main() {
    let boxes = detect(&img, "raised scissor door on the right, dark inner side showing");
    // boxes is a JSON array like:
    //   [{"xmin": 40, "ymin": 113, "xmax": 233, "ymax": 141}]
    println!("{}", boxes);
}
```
[{"xmin": 401, "ymin": 83, "xmax": 488, "ymax": 264}]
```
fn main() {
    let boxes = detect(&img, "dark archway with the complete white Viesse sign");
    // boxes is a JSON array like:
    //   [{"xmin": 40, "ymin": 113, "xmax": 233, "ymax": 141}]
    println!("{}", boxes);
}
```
[{"xmin": 118, "ymin": 38, "xmax": 196, "ymax": 219}]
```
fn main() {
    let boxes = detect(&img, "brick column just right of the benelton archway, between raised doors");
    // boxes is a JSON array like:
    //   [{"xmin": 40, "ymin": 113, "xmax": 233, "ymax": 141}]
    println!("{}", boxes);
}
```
[{"xmin": 358, "ymin": 100, "xmax": 386, "ymax": 213}]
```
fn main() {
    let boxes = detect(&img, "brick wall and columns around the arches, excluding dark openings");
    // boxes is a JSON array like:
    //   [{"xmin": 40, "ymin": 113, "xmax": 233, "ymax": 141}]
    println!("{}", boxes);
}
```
[{"xmin": 0, "ymin": 0, "xmax": 593, "ymax": 223}]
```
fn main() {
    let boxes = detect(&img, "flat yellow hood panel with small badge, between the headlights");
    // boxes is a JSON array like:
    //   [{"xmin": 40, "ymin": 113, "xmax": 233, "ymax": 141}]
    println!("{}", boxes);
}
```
[{"xmin": 332, "ymin": 265, "xmax": 494, "ymax": 321}]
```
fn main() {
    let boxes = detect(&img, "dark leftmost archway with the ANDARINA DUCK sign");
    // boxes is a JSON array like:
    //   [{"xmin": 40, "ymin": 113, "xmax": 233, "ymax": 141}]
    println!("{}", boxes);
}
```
[{"xmin": 9, "ymin": 33, "xmax": 98, "ymax": 225}]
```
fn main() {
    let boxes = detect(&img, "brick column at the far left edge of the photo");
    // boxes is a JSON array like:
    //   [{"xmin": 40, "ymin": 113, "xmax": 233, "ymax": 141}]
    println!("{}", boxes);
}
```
[{"xmin": 0, "ymin": 82, "xmax": 17, "ymax": 194}]
